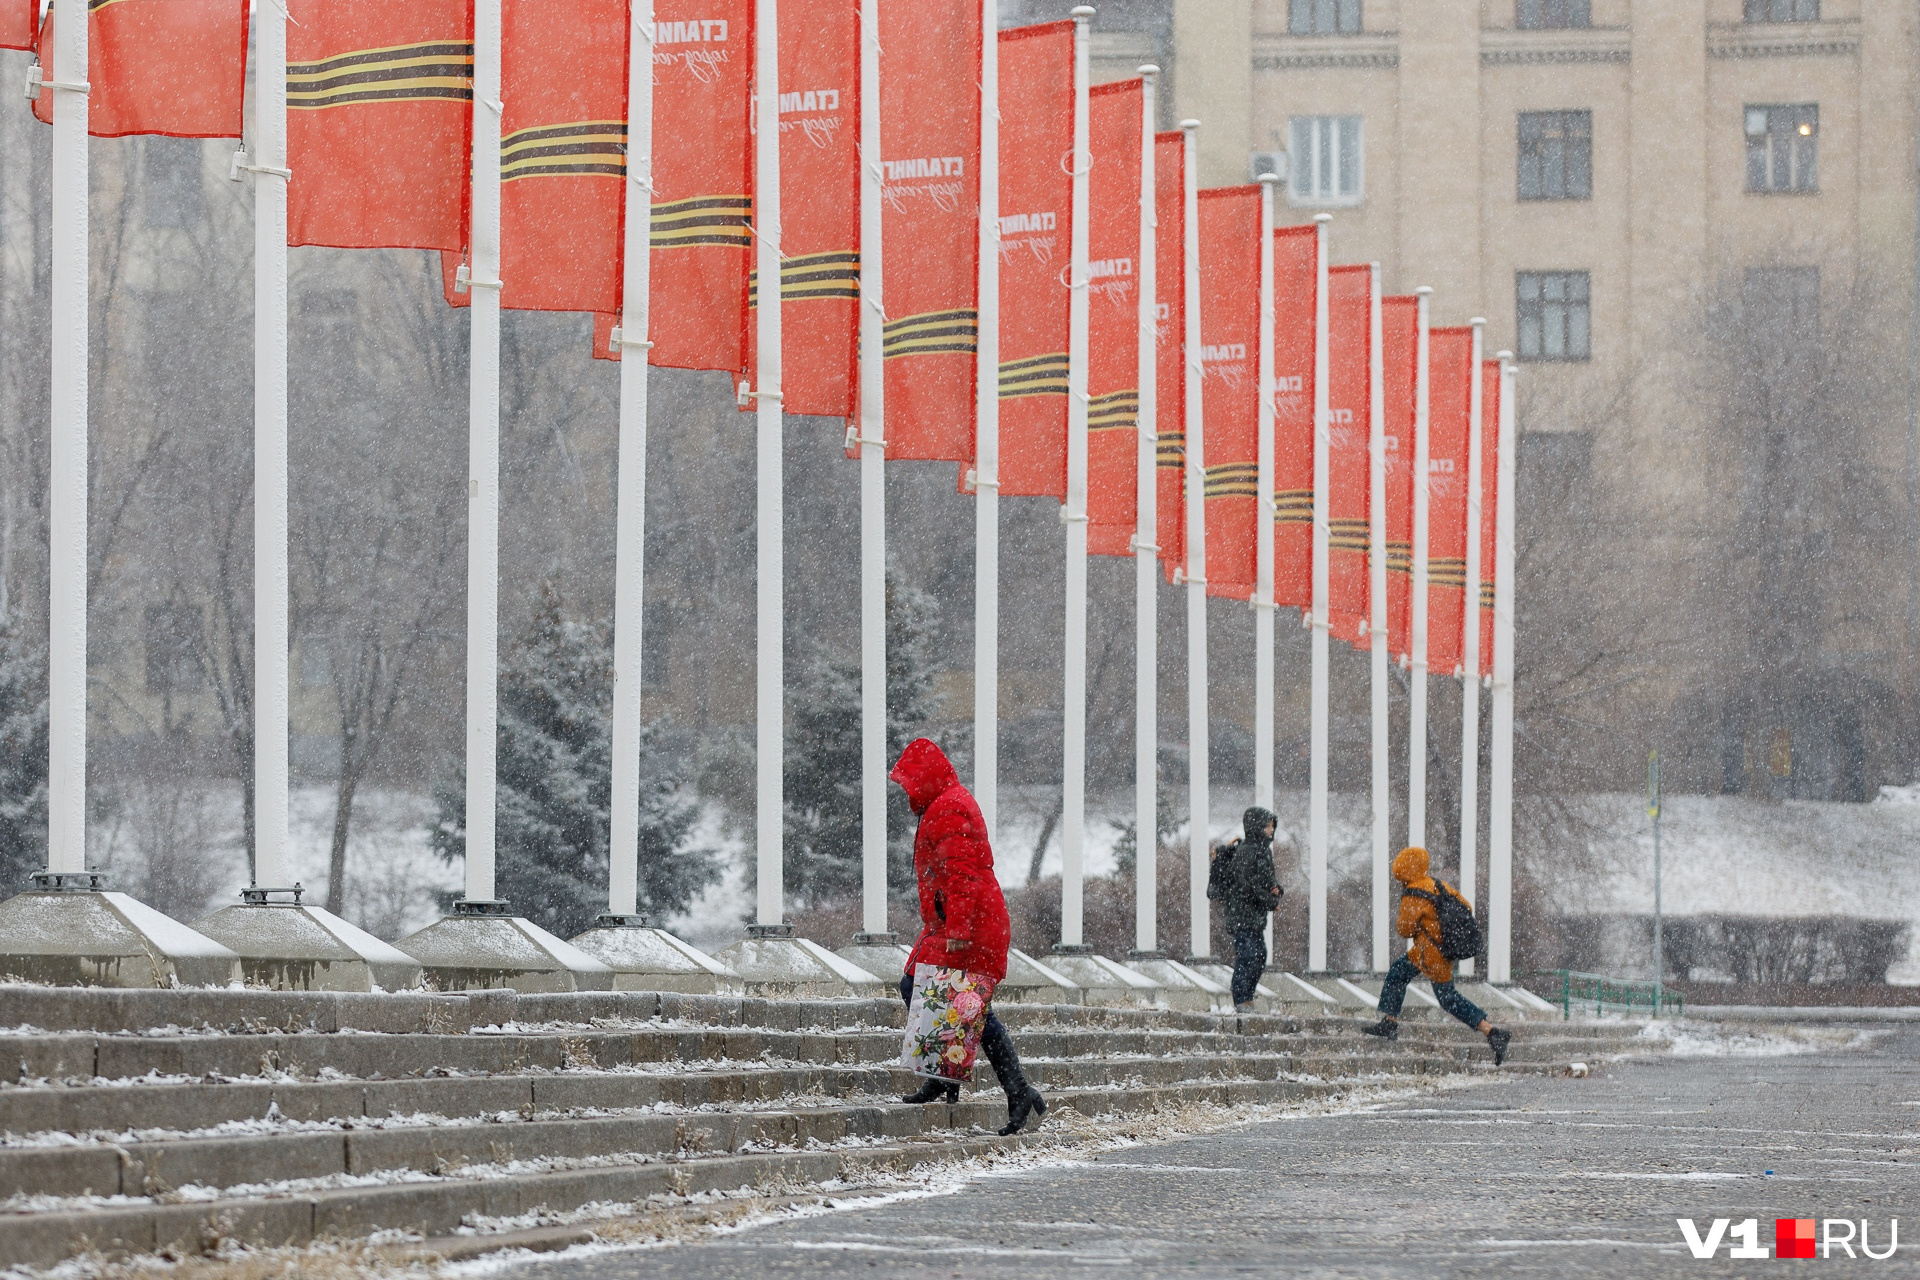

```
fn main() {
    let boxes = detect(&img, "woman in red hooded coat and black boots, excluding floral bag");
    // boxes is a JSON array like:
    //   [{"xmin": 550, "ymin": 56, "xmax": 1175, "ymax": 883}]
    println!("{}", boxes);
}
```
[{"xmin": 889, "ymin": 737, "xmax": 1046, "ymax": 1134}]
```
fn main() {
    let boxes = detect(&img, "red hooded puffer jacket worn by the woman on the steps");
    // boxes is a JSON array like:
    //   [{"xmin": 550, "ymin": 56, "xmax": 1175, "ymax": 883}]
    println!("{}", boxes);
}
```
[{"xmin": 889, "ymin": 737, "xmax": 1010, "ymax": 981}]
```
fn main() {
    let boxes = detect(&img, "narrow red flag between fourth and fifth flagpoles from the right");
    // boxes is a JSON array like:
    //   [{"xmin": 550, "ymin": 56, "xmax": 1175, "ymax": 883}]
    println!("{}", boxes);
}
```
[{"xmin": 1327, "ymin": 267, "xmax": 1373, "ymax": 645}]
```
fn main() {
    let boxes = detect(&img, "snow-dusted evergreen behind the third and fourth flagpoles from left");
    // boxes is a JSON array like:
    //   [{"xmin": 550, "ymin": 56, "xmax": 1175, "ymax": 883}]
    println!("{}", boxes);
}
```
[{"xmin": 432, "ymin": 583, "xmax": 718, "ymax": 938}]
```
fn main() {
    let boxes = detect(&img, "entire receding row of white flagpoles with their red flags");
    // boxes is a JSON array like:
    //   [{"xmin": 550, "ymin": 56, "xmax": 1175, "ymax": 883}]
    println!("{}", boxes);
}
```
[{"xmin": 11, "ymin": 0, "xmax": 1515, "ymax": 981}]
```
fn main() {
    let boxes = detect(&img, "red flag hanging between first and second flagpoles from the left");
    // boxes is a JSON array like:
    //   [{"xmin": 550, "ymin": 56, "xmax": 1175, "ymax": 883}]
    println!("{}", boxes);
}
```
[{"xmin": 34, "ymin": 0, "xmax": 246, "ymax": 138}]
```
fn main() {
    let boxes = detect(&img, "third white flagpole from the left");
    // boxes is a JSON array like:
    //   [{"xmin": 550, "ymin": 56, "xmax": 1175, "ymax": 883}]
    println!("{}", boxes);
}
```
[{"xmin": 467, "ymin": 0, "xmax": 501, "ymax": 904}]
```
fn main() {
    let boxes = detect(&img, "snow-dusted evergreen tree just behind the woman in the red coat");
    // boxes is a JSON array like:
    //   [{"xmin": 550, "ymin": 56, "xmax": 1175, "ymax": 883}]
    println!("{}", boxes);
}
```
[{"xmin": 785, "ymin": 566, "xmax": 952, "ymax": 904}]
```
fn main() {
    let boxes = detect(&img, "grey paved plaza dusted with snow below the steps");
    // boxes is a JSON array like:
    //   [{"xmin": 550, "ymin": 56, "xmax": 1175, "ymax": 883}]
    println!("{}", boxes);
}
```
[{"xmin": 513, "ymin": 1027, "xmax": 1920, "ymax": 1280}]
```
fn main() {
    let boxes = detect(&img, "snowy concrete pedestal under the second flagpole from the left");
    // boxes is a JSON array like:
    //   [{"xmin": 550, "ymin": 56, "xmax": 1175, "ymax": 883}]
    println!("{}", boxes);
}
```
[{"xmin": 194, "ymin": 890, "xmax": 420, "ymax": 990}]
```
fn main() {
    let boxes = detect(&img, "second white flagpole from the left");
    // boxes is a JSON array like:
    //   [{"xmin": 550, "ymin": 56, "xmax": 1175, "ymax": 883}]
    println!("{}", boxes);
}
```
[{"xmin": 253, "ymin": 4, "xmax": 292, "ymax": 889}]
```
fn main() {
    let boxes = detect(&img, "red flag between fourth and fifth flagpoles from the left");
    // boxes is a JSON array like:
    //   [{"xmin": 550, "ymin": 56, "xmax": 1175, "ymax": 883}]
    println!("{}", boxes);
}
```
[{"xmin": 652, "ymin": 0, "xmax": 753, "ymax": 372}]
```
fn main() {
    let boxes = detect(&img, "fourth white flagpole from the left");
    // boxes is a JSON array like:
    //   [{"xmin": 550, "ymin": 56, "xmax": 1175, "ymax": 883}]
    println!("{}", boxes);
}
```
[{"xmin": 607, "ymin": 0, "xmax": 664, "ymax": 915}]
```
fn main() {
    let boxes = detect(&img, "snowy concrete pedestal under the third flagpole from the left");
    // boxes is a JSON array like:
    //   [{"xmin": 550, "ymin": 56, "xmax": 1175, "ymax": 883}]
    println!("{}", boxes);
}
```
[{"xmin": 397, "ymin": 902, "xmax": 612, "ymax": 992}]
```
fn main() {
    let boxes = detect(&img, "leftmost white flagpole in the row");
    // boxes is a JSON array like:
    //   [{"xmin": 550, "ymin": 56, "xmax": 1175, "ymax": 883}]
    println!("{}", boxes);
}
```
[{"xmin": 40, "ymin": 0, "xmax": 88, "ymax": 885}]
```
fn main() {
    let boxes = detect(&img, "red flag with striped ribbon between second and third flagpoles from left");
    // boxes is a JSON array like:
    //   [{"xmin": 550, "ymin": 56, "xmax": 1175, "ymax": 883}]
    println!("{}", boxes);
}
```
[{"xmin": 286, "ymin": 0, "xmax": 474, "ymax": 249}]
